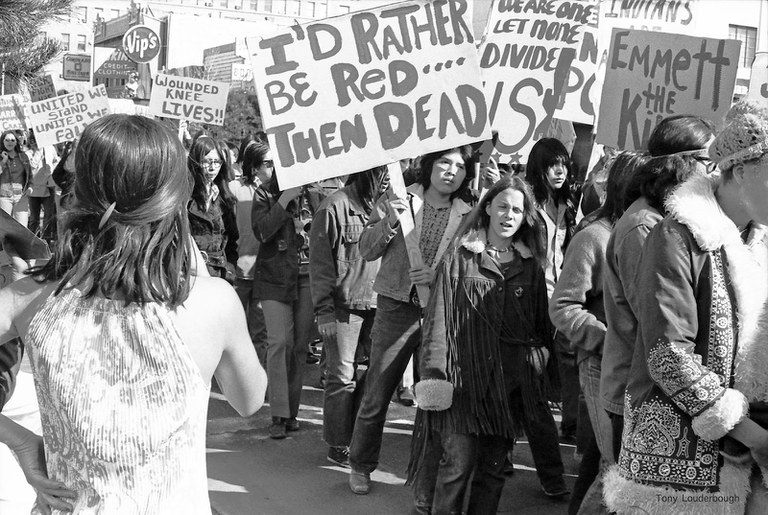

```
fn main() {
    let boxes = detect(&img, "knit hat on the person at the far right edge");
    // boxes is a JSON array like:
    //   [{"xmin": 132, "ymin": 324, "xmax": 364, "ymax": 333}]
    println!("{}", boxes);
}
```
[{"xmin": 709, "ymin": 111, "xmax": 768, "ymax": 171}]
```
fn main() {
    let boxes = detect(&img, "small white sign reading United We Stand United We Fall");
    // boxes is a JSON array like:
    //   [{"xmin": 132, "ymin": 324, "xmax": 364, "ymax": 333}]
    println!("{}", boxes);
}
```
[{"xmin": 29, "ymin": 84, "xmax": 110, "ymax": 147}]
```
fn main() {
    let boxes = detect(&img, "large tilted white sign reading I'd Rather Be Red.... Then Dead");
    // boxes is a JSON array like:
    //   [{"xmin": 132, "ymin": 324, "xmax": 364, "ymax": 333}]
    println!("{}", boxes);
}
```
[{"xmin": 247, "ymin": 0, "xmax": 491, "ymax": 189}]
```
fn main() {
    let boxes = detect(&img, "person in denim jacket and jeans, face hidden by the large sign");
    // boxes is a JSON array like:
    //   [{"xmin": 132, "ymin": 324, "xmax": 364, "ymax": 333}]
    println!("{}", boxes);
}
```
[{"xmin": 309, "ymin": 166, "xmax": 388, "ymax": 467}]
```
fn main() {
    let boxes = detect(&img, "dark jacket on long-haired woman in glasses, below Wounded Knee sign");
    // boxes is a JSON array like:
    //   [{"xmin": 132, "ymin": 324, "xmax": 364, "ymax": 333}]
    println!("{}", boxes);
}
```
[{"xmin": 187, "ymin": 195, "xmax": 240, "ymax": 279}]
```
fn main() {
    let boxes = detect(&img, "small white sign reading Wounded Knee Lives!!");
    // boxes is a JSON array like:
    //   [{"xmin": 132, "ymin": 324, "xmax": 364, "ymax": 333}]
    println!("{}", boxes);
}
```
[{"xmin": 149, "ymin": 73, "xmax": 229, "ymax": 125}]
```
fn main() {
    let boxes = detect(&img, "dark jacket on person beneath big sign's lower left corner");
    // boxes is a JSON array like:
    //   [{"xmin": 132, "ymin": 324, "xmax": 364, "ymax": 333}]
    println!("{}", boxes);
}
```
[{"xmin": 251, "ymin": 180, "xmax": 323, "ymax": 302}]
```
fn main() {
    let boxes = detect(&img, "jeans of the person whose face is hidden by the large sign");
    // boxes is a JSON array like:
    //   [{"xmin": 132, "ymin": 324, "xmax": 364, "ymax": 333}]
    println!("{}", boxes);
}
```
[{"xmin": 323, "ymin": 308, "xmax": 376, "ymax": 447}]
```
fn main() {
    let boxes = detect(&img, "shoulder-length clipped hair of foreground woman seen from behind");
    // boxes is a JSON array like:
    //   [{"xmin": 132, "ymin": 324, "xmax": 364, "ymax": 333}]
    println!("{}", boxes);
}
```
[{"xmin": 31, "ymin": 114, "xmax": 192, "ymax": 307}]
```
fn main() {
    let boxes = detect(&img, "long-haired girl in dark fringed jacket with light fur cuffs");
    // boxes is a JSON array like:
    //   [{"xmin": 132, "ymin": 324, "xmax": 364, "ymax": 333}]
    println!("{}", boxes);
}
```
[{"xmin": 409, "ymin": 177, "xmax": 563, "ymax": 514}]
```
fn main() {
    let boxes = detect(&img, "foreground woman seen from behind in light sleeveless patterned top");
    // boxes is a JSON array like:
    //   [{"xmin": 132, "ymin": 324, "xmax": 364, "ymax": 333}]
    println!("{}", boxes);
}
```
[{"xmin": 0, "ymin": 114, "xmax": 266, "ymax": 515}]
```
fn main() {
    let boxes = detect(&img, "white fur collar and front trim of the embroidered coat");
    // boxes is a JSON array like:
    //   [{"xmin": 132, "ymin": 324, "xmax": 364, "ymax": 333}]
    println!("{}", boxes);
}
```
[{"xmin": 667, "ymin": 175, "xmax": 768, "ymax": 401}]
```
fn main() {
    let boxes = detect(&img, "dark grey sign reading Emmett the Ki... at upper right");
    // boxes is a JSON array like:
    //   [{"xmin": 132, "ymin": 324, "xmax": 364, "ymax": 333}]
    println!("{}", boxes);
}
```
[{"xmin": 597, "ymin": 29, "xmax": 741, "ymax": 150}]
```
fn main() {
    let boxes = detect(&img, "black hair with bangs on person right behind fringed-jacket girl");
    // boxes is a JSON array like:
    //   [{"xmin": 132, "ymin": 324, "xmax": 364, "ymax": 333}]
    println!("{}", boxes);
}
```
[{"xmin": 525, "ymin": 138, "xmax": 573, "ymax": 210}]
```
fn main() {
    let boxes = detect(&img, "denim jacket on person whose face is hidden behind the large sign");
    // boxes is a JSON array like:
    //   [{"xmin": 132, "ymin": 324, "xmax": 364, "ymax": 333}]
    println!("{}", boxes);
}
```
[{"xmin": 309, "ymin": 186, "xmax": 379, "ymax": 324}]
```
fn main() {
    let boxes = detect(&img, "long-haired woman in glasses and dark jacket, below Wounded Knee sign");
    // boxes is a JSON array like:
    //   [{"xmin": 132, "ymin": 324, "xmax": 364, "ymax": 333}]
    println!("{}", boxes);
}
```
[{"xmin": 187, "ymin": 135, "xmax": 239, "ymax": 282}]
